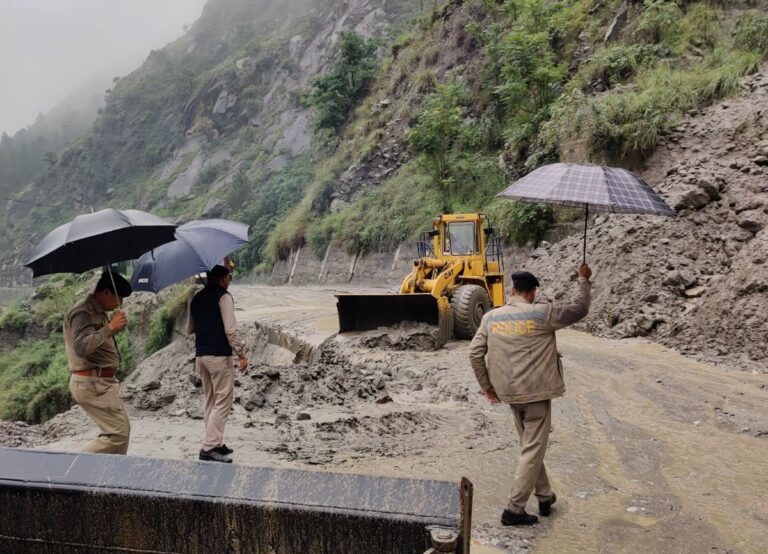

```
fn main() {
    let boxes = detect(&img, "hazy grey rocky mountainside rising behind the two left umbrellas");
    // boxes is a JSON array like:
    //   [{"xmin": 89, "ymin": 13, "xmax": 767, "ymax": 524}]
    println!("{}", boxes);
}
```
[{"xmin": 0, "ymin": 0, "xmax": 415, "ymax": 283}]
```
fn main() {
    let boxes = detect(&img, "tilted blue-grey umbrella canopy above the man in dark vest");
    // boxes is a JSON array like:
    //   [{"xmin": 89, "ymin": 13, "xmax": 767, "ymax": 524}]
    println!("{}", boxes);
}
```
[{"xmin": 131, "ymin": 219, "xmax": 248, "ymax": 292}]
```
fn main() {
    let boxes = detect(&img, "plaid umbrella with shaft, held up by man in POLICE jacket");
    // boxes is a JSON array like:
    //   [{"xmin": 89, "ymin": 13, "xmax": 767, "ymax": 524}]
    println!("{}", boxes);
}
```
[{"xmin": 498, "ymin": 163, "xmax": 675, "ymax": 260}]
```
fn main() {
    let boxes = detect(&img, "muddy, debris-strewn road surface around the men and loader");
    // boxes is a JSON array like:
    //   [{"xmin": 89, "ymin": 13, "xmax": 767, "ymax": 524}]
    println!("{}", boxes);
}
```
[{"xmin": 7, "ymin": 286, "xmax": 768, "ymax": 553}]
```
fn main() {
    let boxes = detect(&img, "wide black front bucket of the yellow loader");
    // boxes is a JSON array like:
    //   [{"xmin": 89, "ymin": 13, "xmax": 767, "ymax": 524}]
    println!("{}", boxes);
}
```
[{"xmin": 336, "ymin": 293, "xmax": 439, "ymax": 333}]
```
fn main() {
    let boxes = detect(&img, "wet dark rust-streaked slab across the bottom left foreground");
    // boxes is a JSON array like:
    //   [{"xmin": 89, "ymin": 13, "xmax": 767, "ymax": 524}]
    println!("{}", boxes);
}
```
[{"xmin": 0, "ymin": 448, "xmax": 472, "ymax": 554}]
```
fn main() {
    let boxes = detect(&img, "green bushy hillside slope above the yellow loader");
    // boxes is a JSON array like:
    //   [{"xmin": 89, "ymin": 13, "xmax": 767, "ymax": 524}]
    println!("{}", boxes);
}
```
[{"xmin": 267, "ymin": 0, "xmax": 768, "ymax": 259}]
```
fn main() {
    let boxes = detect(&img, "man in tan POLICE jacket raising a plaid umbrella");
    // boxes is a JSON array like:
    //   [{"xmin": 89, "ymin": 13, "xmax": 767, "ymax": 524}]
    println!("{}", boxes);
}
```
[{"xmin": 469, "ymin": 264, "xmax": 592, "ymax": 525}]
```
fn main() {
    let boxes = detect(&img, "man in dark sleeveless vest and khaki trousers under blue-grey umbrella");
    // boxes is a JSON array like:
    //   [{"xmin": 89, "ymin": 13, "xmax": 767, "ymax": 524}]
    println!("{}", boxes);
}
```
[{"xmin": 187, "ymin": 265, "xmax": 248, "ymax": 463}]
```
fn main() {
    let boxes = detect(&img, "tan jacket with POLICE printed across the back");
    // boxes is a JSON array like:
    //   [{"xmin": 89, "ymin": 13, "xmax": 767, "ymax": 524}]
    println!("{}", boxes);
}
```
[{"xmin": 469, "ymin": 278, "xmax": 591, "ymax": 404}]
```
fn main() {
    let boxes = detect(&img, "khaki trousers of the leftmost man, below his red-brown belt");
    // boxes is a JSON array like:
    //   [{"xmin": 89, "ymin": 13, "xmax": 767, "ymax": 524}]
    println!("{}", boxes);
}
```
[{"xmin": 69, "ymin": 375, "xmax": 131, "ymax": 454}]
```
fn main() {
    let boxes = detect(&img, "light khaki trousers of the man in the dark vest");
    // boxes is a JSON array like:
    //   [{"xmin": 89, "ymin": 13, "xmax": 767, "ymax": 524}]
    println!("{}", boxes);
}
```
[{"xmin": 195, "ymin": 356, "xmax": 235, "ymax": 452}]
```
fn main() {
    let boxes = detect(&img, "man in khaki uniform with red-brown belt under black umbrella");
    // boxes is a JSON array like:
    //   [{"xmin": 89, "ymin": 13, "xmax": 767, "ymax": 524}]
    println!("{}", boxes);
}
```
[{"xmin": 64, "ymin": 272, "xmax": 132, "ymax": 454}]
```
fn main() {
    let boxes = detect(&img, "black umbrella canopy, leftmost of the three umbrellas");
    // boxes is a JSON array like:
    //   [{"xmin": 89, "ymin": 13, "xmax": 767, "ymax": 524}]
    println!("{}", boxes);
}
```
[{"xmin": 24, "ymin": 208, "xmax": 176, "ymax": 277}]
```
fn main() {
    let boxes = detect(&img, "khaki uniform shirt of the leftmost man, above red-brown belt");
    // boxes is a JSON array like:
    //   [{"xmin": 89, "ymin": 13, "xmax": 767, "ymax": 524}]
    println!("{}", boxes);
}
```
[{"xmin": 64, "ymin": 294, "xmax": 120, "ymax": 372}]
